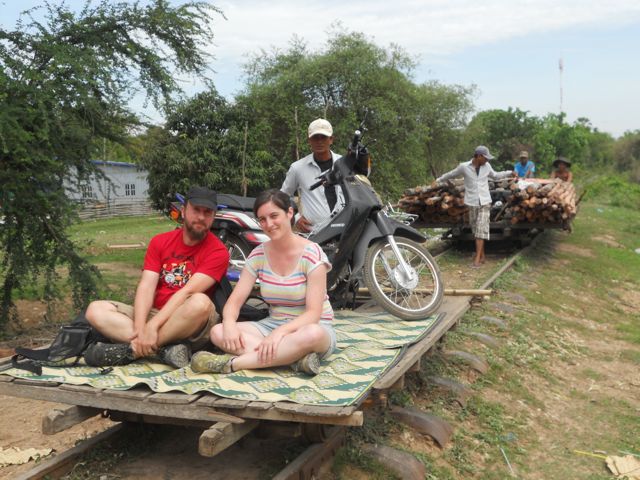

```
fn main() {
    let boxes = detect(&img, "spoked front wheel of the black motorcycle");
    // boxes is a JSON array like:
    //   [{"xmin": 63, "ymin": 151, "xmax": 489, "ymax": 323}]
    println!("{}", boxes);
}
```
[{"xmin": 364, "ymin": 237, "xmax": 444, "ymax": 320}]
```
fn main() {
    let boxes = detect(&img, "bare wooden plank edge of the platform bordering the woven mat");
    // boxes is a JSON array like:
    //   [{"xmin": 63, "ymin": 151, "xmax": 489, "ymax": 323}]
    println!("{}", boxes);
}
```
[{"xmin": 0, "ymin": 290, "xmax": 480, "ymax": 426}]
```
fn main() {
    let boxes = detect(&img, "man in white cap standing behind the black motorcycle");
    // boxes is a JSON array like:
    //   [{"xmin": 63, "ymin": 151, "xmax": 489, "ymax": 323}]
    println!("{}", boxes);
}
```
[{"xmin": 280, "ymin": 118, "xmax": 344, "ymax": 232}]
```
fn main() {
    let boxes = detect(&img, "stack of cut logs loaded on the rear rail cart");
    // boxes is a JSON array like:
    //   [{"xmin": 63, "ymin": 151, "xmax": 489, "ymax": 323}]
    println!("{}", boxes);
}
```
[{"xmin": 398, "ymin": 179, "xmax": 576, "ymax": 224}]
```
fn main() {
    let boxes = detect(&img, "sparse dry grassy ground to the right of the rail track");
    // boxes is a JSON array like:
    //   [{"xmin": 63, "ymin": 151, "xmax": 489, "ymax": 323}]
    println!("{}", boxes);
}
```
[{"xmin": 384, "ymin": 197, "xmax": 640, "ymax": 480}]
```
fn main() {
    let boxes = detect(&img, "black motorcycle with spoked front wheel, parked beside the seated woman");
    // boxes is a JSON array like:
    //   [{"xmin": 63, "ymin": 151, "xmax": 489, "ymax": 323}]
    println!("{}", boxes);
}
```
[{"xmin": 308, "ymin": 124, "xmax": 444, "ymax": 320}]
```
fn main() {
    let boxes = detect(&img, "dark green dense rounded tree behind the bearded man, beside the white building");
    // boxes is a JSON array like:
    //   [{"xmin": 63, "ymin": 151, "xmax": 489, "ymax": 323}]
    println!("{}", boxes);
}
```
[{"xmin": 142, "ymin": 87, "xmax": 281, "ymax": 209}]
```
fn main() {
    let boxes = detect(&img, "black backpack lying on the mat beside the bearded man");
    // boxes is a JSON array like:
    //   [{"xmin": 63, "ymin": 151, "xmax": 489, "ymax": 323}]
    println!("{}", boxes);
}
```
[{"xmin": 11, "ymin": 311, "xmax": 108, "ymax": 375}]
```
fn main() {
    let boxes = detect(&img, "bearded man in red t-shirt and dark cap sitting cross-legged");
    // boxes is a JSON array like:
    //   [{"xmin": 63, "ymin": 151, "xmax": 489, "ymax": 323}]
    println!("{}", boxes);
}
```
[{"xmin": 85, "ymin": 187, "xmax": 229, "ymax": 368}]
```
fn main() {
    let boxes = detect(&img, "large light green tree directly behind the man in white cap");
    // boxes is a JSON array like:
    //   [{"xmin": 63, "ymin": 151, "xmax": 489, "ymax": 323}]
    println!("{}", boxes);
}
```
[{"xmin": 237, "ymin": 29, "xmax": 472, "ymax": 200}]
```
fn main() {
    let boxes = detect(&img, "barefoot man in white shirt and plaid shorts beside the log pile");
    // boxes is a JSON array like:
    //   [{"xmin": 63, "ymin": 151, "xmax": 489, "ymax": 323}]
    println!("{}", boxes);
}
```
[{"xmin": 434, "ymin": 145, "xmax": 514, "ymax": 268}]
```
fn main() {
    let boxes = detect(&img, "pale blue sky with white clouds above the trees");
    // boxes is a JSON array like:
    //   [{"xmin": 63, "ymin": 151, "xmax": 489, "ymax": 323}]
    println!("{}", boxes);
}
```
[{"xmin": 0, "ymin": 0, "xmax": 640, "ymax": 136}]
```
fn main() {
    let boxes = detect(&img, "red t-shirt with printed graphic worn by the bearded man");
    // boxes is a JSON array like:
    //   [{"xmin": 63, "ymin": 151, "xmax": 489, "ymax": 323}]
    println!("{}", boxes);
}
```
[{"xmin": 142, "ymin": 228, "xmax": 229, "ymax": 309}]
